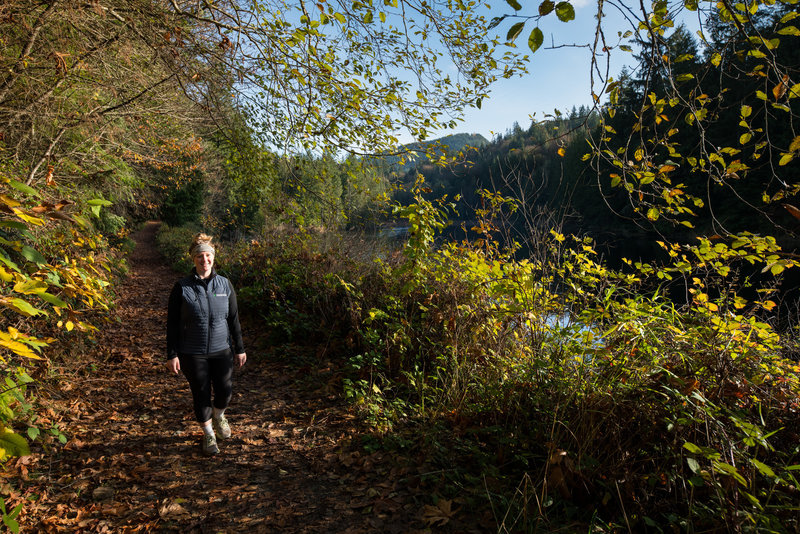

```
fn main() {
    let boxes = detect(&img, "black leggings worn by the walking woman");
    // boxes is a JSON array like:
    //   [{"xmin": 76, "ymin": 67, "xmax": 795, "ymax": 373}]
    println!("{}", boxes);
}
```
[{"xmin": 179, "ymin": 352, "xmax": 233, "ymax": 423}]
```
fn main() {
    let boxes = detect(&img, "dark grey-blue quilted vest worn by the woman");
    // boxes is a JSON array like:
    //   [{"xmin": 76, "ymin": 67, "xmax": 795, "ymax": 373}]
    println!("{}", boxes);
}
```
[{"xmin": 178, "ymin": 274, "xmax": 232, "ymax": 354}]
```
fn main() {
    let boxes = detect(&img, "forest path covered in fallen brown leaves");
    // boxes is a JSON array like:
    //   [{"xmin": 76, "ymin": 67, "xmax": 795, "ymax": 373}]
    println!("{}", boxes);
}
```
[{"xmin": 6, "ymin": 223, "xmax": 440, "ymax": 533}]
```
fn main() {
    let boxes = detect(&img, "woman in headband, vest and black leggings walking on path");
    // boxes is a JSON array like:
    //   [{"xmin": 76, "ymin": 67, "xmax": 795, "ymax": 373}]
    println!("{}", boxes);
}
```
[{"xmin": 167, "ymin": 234, "xmax": 247, "ymax": 455}]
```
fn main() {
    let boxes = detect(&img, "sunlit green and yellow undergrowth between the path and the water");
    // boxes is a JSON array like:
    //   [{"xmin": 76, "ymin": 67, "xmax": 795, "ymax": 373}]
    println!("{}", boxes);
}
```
[{"xmin": 156, "ymin": 195, "xmax": 800, "ymax": 532}]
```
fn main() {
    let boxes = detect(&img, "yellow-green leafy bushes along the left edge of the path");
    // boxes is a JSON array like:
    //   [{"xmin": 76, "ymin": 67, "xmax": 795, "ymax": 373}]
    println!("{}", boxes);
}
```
[{"xmin": 0, "ymin": 176, "xmax": 127, "ymax": 468}]
